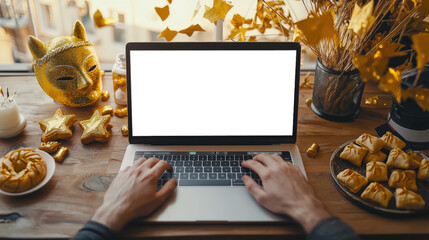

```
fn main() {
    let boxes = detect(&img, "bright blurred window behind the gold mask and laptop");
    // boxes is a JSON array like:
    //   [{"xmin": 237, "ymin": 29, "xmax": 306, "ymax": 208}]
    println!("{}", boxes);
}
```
[{"xmin": 0, "ymin": 0, "xmax": 314, "ymax": 71}]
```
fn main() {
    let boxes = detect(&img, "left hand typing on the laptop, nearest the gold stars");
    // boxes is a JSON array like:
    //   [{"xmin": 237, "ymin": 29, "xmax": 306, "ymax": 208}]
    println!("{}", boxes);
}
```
[{"xmin": 91, "ymin": 158, "xmax": 177, "ymax": 231}]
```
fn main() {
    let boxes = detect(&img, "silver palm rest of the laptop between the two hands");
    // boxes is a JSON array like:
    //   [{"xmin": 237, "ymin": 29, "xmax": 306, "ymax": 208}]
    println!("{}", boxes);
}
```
[{"xmin": 146, "ymin": 186, "xmax": 290, "ymax": 222}]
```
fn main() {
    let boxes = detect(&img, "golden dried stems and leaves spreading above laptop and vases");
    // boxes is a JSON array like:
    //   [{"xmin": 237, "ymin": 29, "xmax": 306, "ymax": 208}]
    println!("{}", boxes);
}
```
[{"xmin": 149, "ymin": 0, "xmax": 429, "ymax": 111}]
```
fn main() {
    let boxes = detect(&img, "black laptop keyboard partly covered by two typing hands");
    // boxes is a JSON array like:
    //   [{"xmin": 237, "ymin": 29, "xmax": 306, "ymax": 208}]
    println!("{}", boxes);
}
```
[{"xmin": 134, "ymin": 151, "xmax": 292, "ymax": 188}]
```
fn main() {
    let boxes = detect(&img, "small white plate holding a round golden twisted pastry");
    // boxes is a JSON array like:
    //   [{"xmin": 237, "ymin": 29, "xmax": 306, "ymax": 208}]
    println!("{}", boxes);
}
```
[{"xmin": 0, "ymin": 148, "xmax": 55, "ymax": 196}]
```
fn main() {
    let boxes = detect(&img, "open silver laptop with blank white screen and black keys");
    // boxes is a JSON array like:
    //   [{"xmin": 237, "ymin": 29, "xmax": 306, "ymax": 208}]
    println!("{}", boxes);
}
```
[{"xmin": 121, "ymin": 42, "xmax": 305, "ymax": 222}]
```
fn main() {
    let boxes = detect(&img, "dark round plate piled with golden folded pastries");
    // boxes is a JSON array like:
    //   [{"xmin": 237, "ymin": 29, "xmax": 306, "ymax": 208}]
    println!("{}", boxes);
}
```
[{"xmin": 330, "ymin": 132, "xmax": 429, "ymax": 216}]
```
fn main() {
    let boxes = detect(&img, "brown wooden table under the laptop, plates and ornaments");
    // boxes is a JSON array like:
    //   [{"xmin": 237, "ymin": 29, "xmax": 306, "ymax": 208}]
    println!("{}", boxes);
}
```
[{"xmin": 0, "ymin": 73, "xmax": 429, "ymax": 239}]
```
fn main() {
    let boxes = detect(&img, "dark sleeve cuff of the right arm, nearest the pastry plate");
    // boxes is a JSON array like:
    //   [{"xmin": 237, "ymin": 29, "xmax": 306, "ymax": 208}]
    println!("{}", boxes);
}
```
[{"xmin": 307, "ymin": 217, "xmax": 360, "ymax": 240}]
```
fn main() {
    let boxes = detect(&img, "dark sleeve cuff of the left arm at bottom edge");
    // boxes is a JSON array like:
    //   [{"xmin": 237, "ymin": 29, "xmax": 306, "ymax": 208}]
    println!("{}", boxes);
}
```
[{"xmin": 70, "ymin": 221, "xmax": 119, "ymax": 240}]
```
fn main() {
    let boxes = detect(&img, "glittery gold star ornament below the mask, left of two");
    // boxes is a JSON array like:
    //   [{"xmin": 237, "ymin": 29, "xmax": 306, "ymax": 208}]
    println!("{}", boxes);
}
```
[{"xmin": 39, "ymin": 109, "xmax": 77, "ymax": 142}]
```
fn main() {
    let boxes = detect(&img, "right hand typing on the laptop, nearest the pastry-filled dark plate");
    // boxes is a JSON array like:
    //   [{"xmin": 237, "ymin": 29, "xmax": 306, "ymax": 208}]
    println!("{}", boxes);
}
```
[{"xmin": 242, "ymin": 154, "xmax": 329, "ymax": 233}]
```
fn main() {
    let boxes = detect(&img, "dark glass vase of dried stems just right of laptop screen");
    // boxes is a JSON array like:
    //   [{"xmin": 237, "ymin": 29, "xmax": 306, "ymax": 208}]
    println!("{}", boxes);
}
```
[{"xmin": 311, "ymin": 59, "xmax": 365, "ymax": 122}]
